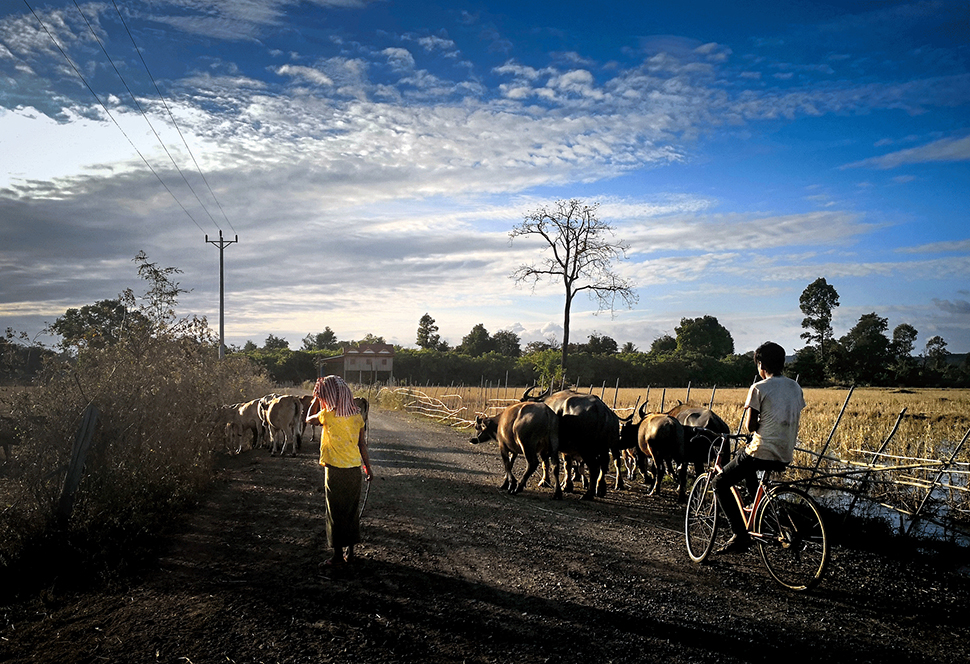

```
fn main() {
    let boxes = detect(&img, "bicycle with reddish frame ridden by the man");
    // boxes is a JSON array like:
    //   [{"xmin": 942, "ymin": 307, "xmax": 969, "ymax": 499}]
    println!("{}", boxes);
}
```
[{"xmin": 684, "ymin": 432, "xmax": 829, "ymax": 592}]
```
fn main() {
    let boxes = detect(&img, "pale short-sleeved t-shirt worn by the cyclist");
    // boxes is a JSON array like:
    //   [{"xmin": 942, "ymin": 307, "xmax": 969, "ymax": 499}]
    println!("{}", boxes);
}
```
[{"xmin": 744, "ymin": 376, "xmax": 805, "ymax": 463}]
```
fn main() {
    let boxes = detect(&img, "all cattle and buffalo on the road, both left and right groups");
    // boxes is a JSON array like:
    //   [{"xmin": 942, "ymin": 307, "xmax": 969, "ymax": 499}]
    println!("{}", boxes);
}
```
[{"xmin": 216, "ymin": 388, "xmax": 731, "ymax": 502}]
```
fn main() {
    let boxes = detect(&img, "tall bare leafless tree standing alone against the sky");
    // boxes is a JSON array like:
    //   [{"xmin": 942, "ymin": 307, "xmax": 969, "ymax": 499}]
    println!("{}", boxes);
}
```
[{"xmin": 509, "ymin": 199, "xmax": 637, "ymax": 373}]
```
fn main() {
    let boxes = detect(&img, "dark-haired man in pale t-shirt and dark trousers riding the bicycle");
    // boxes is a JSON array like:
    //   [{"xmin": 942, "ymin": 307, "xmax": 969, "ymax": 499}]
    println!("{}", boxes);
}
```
[{"xmin": 714, "ymin": 341, "xmax": 805, "ymax": 553}]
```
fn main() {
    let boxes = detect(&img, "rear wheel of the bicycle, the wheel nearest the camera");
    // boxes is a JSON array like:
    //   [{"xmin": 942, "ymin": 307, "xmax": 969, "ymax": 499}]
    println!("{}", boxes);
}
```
[{"xmin": 755, "ymin": 487, "xmax": 829, "ymax": 591}]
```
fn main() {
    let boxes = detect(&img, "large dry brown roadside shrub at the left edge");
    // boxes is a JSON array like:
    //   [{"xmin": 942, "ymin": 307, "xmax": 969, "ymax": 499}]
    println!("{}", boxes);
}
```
[{"xmin": 0, "ymin": 255, "xmax": 272, "ymax": 590}]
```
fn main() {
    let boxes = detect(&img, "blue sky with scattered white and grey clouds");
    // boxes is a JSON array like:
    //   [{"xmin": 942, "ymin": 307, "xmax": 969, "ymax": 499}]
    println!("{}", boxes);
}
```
[{"xmin": 0, "ymin": 0, "xmax": 970, "ymax": 353}]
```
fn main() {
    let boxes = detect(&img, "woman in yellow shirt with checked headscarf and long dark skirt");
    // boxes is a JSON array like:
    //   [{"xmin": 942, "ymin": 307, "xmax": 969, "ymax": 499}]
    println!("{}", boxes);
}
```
[{"xmin": 306, "ymin": 376, "xmax": 374, "ymax": 565}]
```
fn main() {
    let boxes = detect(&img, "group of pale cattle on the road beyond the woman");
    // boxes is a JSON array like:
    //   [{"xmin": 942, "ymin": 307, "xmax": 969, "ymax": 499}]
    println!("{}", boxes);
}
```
[{"xmin": 215, "ymin": 394, "xmax": 370, "ymax": 456}]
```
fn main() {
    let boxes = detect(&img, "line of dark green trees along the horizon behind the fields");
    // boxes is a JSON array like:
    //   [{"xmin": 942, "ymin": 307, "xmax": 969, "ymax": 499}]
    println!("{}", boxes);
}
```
[{"xmin": 0, "ymin": 278, "xmax": 970, "ymax": 387}]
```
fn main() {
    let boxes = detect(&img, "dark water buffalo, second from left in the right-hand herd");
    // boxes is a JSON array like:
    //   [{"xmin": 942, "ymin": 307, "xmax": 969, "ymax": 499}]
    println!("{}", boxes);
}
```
[{"xmin": 521, "ymin": 388, "xmax": 622, "ymax": 500}]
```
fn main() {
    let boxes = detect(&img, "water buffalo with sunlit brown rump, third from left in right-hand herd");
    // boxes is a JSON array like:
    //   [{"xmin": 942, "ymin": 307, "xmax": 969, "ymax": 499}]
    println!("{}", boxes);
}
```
[{"xmin": 620, "ymin": 404, "xmax": 710, "ymax": 502}]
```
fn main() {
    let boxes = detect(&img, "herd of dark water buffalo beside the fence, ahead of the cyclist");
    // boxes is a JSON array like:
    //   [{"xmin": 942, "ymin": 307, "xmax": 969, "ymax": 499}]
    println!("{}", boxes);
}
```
[{"xmin": 470, "ymin": 389, "xmax": 730, "ymax": 502}]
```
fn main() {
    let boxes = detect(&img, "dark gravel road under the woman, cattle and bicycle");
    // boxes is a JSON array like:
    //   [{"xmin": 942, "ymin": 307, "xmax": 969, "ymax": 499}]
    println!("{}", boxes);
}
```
[{"xmin": 0, "ymin": 411, "xmax": 970, "ymax": 664}]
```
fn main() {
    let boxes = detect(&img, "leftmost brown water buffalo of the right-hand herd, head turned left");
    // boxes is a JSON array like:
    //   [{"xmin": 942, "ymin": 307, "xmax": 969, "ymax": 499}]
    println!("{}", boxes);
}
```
[{"xmin": 469, "ymin": 401, "xmax": 562, "ymax": 500}]
